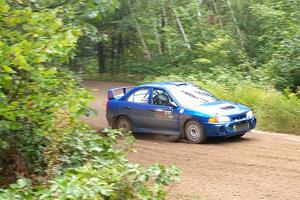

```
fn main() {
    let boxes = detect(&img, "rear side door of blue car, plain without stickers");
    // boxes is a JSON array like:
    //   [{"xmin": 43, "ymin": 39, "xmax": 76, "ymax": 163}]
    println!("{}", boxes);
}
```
[{"xmin": 120, "ymin": 88, "xmax": 151, "ymax": 131}]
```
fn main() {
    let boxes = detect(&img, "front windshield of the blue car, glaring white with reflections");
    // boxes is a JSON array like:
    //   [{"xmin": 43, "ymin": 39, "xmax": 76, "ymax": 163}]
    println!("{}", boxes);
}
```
[{"xmin": 168, "ymin": 84, "xmax": 219, "ymax": 107}]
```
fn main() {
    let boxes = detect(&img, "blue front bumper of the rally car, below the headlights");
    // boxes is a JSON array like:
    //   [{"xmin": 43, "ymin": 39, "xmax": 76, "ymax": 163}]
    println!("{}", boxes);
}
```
[{"xmin": 202, "ymin": 117, "xmax": 256, "ymax": 137}]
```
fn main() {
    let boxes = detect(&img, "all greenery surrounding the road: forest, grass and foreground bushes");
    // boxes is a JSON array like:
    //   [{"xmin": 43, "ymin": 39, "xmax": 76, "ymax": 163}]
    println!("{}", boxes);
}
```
[{"xmin": 0, "ymin": 0, "xmax": 300, "ymax": 199}]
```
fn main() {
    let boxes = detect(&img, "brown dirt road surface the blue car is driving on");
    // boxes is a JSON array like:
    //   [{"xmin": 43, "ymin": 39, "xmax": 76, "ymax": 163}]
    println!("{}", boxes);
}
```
[{"xmin": 85, "ymin": 81, "xmax": 300, "ymax": 200}]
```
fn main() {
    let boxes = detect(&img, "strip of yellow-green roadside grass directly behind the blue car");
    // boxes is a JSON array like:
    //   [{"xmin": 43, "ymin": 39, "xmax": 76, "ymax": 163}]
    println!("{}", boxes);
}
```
[{"xmin": 85, "ymin": 73, "xmax": 300, "ymax": 135}]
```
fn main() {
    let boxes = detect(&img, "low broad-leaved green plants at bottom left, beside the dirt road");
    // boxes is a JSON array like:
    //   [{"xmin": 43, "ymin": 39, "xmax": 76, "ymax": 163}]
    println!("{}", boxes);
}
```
[{"xmin": 0, "ymin": 130, "xmax": 180, "ymax": 199}]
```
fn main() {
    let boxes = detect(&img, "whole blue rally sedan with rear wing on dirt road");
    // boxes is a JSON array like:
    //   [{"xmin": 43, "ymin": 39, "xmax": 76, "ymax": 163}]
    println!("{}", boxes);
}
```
[{"xmin": 106, "ymin": 82, "xmax": 256, "ymax": 143}]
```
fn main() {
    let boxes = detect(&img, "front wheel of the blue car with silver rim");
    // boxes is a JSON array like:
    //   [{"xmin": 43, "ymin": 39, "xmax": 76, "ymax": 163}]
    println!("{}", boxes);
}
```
[{"xmin": 184, "ymin": 120, "xmax": 206, "ymax": 144}]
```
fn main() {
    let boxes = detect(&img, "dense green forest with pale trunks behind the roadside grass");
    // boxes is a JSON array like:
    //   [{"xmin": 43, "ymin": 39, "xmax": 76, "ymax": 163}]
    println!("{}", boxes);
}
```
[{"xmin": 77, "ymin": 0, "xmax": 300, "ymax": 92}]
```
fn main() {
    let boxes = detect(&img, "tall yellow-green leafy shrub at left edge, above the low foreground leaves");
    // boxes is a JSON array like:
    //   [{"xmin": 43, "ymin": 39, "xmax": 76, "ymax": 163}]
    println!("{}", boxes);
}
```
[{"xmin": 0, "ymin": 1, "xmax": 91, "ymax": 179}]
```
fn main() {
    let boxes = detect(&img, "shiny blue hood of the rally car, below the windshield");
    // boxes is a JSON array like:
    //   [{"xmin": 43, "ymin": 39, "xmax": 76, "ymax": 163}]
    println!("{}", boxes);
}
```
[{"xmin": 185, "ymin": 100, "xmax": 250, "ymax": 116}]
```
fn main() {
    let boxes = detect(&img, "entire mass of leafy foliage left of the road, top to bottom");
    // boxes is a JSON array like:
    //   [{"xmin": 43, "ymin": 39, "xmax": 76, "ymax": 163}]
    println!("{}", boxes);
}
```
[{"xmin": 0, "ymin": 0, "xmax": 179, "ymax": 200}]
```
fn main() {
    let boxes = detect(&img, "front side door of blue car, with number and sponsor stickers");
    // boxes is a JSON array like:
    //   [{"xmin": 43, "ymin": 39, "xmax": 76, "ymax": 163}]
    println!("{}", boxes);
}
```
[{"xmin": 149, "ymin": 88, "xmax": 179, "ymax": 131}]
